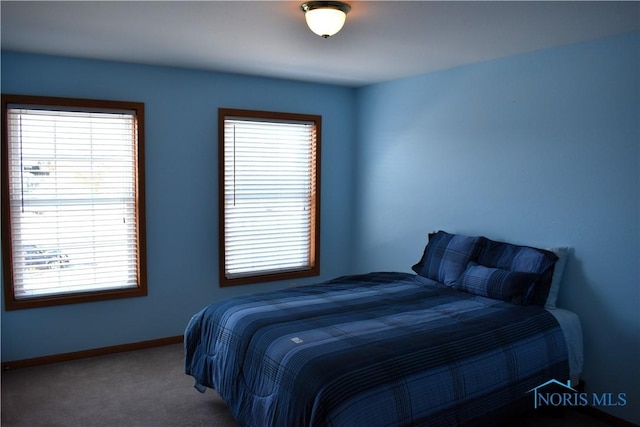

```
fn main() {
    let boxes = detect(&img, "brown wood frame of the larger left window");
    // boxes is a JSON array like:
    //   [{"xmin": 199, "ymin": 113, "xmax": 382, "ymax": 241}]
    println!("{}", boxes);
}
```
[{"xmin": 1, "ymin": 94, "xmax": 147, "ymax": 310}]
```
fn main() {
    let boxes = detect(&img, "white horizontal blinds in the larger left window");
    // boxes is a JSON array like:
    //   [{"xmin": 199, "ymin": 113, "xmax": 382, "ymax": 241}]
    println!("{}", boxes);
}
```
[{"xmin": 8, "ymin": 106, "xmax": 138, "ymax": 299}]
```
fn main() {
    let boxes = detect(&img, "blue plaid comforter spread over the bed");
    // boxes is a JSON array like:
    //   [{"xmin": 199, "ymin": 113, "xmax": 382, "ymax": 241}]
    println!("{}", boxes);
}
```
[{"xmin": 185, "ymin": 273, "xmax": 569, "ymax": 427}]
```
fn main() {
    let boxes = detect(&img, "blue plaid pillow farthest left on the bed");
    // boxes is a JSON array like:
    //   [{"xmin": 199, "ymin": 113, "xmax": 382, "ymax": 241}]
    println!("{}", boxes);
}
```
[{"xmin": 411, "ymin": 230, "xmax": 482, "ymax": 286}]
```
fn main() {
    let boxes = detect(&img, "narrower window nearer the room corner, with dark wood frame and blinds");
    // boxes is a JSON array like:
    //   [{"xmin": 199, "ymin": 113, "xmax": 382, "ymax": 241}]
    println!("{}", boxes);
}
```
[{"xmin": 219, "ymin": 109, "xmax": 321, "ymax": 286}]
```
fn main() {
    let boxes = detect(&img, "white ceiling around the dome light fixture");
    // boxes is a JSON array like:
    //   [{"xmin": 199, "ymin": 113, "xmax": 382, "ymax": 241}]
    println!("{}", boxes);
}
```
[{"xmin": 0, "ymin": 0, "xmax": 640, "ymax": 86}]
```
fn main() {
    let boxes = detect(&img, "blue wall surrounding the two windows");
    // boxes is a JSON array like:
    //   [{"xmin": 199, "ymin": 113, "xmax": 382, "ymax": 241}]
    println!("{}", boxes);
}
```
[{"xmin": 2, "ymin": 52, "xmax": 355, "ymax": 361}]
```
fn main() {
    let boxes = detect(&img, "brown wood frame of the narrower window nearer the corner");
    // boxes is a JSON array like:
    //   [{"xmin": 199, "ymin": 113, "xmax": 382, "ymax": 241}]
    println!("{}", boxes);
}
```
[{"xmin": 218, "ymin": 108, "xmax": 322, "ymax": 286}]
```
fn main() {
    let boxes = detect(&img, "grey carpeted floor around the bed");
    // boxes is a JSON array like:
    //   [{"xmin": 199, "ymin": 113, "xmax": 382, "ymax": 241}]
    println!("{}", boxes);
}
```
[{"xmin": 0, "ymin": 344, "xmax": 607, "ymax": 427}]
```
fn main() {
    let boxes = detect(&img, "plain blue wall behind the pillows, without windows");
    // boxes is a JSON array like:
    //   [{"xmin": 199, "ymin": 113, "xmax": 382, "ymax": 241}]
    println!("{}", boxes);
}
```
[{"xmin": 353, "ymin": 33, "xmax": 640, "ymax": 423}]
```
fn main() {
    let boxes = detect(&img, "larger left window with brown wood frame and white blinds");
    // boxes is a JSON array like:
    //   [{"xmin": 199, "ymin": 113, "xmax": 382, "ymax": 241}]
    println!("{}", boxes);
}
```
[{"xmin": 2, "ymin": 95, "xmax": 147, "ymax": 310}]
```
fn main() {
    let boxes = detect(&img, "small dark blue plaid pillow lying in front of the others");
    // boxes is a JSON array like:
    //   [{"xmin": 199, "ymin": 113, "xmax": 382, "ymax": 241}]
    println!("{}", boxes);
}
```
[{"xmin": 456, "ymin": 262, "xmax": 539, "ymax": 305}]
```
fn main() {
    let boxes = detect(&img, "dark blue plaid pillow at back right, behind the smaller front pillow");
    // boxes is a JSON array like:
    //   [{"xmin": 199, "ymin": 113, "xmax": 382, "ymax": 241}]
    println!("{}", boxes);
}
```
[{"xmin": 477, "ymin": 238, "xmax": 558, "ymax": 306}]
